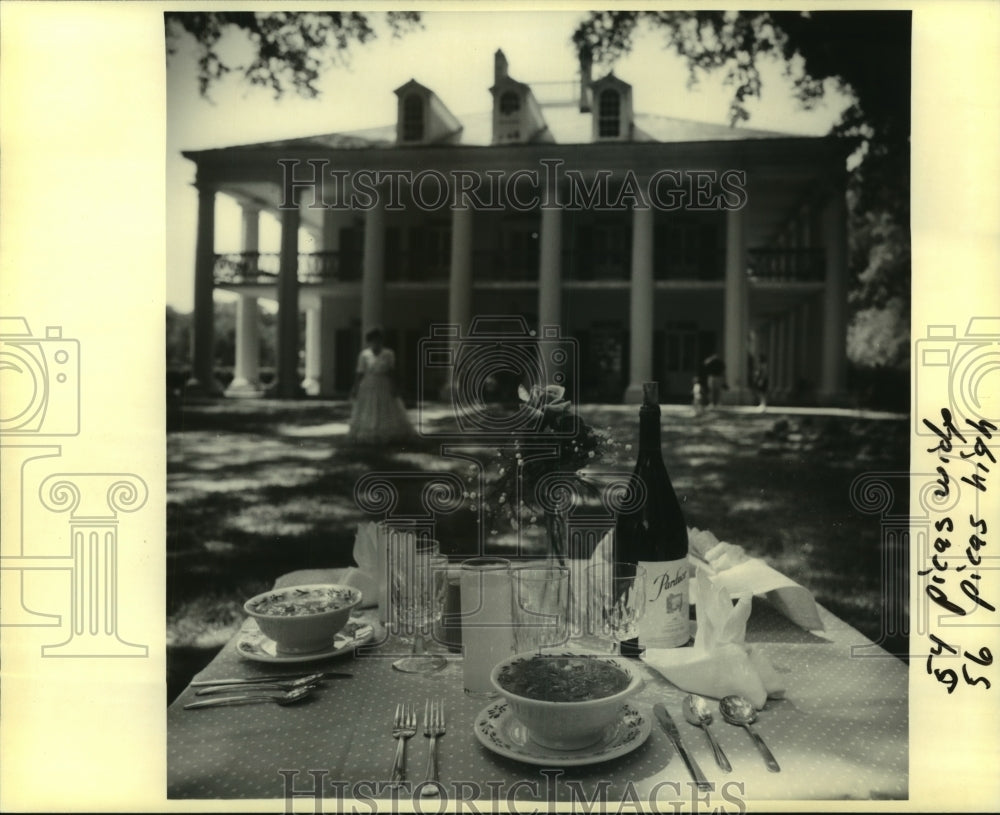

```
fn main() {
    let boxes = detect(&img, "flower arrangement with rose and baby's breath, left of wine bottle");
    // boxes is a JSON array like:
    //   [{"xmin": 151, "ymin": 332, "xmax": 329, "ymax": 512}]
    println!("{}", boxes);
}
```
[{"xmin": 466, "ymin": 385, "xmax": 632, "ymax": 562}]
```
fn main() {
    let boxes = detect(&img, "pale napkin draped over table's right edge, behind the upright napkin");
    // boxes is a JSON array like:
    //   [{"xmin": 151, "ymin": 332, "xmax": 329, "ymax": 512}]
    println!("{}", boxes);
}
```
[{"xmin": 688, "ymin": 528, "xmax": 824, "ymax": 631}]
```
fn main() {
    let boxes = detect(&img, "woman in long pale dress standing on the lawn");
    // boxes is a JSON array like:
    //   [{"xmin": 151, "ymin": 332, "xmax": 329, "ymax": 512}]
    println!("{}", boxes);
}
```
[{"xmin": 348, "ymin": 328, "xmax": 416, "ymax": 444}]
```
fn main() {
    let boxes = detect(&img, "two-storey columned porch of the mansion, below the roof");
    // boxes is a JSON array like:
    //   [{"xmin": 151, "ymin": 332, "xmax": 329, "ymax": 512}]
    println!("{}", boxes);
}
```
[{"xmin": 189, "ymin": 140, "xmax": 847, "ymax": 404}]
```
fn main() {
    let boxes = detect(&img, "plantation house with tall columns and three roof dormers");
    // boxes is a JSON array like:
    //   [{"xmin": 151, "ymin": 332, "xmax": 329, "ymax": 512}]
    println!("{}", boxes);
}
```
[{"xmin": 184, "ymin": 51, "xmax": 850, "ymax": 403}]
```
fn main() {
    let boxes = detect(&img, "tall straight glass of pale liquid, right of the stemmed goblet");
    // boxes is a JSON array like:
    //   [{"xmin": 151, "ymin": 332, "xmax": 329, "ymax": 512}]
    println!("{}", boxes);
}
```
[{"xmin": 460, "ymin": 557, "xmax": 514, "ymax": 698}]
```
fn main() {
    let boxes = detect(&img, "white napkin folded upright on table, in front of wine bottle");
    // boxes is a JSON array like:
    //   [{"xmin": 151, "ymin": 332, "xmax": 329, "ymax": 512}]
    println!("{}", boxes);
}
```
[{"xmin": 642, "ymin": 570, "xmax": 785, "ymax": 710}]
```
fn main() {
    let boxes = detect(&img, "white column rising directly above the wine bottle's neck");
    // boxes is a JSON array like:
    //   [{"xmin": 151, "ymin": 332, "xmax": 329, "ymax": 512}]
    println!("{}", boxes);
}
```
[{"xmin": 625, "ymin": 208, "xmax": 655, "ymax": 404}]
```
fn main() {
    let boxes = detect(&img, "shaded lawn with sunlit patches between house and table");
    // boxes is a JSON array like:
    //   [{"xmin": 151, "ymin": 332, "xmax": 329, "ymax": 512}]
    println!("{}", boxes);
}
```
[{"xmin": 167, "ymin": 400, "xmax": 909, "ymax": 698}]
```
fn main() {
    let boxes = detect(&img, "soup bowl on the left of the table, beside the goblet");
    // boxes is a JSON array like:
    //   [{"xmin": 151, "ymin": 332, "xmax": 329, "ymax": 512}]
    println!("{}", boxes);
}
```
[{"xmin": 243, "ymin": 583, "xmax": 361, "ymax": 654}]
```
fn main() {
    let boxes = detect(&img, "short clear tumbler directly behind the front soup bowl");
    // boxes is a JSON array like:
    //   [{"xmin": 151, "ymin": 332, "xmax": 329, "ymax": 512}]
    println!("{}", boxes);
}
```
[{"xmin": 511, "ymin": 564, "xmax": 569, "ymax": 653}]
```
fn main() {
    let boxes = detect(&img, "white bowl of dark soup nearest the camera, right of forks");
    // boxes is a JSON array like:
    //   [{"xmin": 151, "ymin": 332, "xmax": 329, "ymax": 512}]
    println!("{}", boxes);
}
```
[{"xmin": 490, "ymin": 651, "xmax": 642, "ymax": 750}]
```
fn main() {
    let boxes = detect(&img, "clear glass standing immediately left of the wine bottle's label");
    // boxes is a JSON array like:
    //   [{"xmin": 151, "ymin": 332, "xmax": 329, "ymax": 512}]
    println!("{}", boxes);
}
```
[{"xmin": 587, "ymin": 562, "xmax": 646, "ymax": 654}]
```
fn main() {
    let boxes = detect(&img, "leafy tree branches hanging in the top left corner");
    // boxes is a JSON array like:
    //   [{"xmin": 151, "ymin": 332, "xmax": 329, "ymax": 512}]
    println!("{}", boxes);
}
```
[{"xmin": 163, "ymin": 11, "xmax": 420, "ymax": 98}]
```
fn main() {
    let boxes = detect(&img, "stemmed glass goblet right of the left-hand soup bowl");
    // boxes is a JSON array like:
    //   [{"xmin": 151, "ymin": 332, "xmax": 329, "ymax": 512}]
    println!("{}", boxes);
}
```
[{"xmin": 388, "ymin": 529, "xmax": 448, "ymax": 673}]
